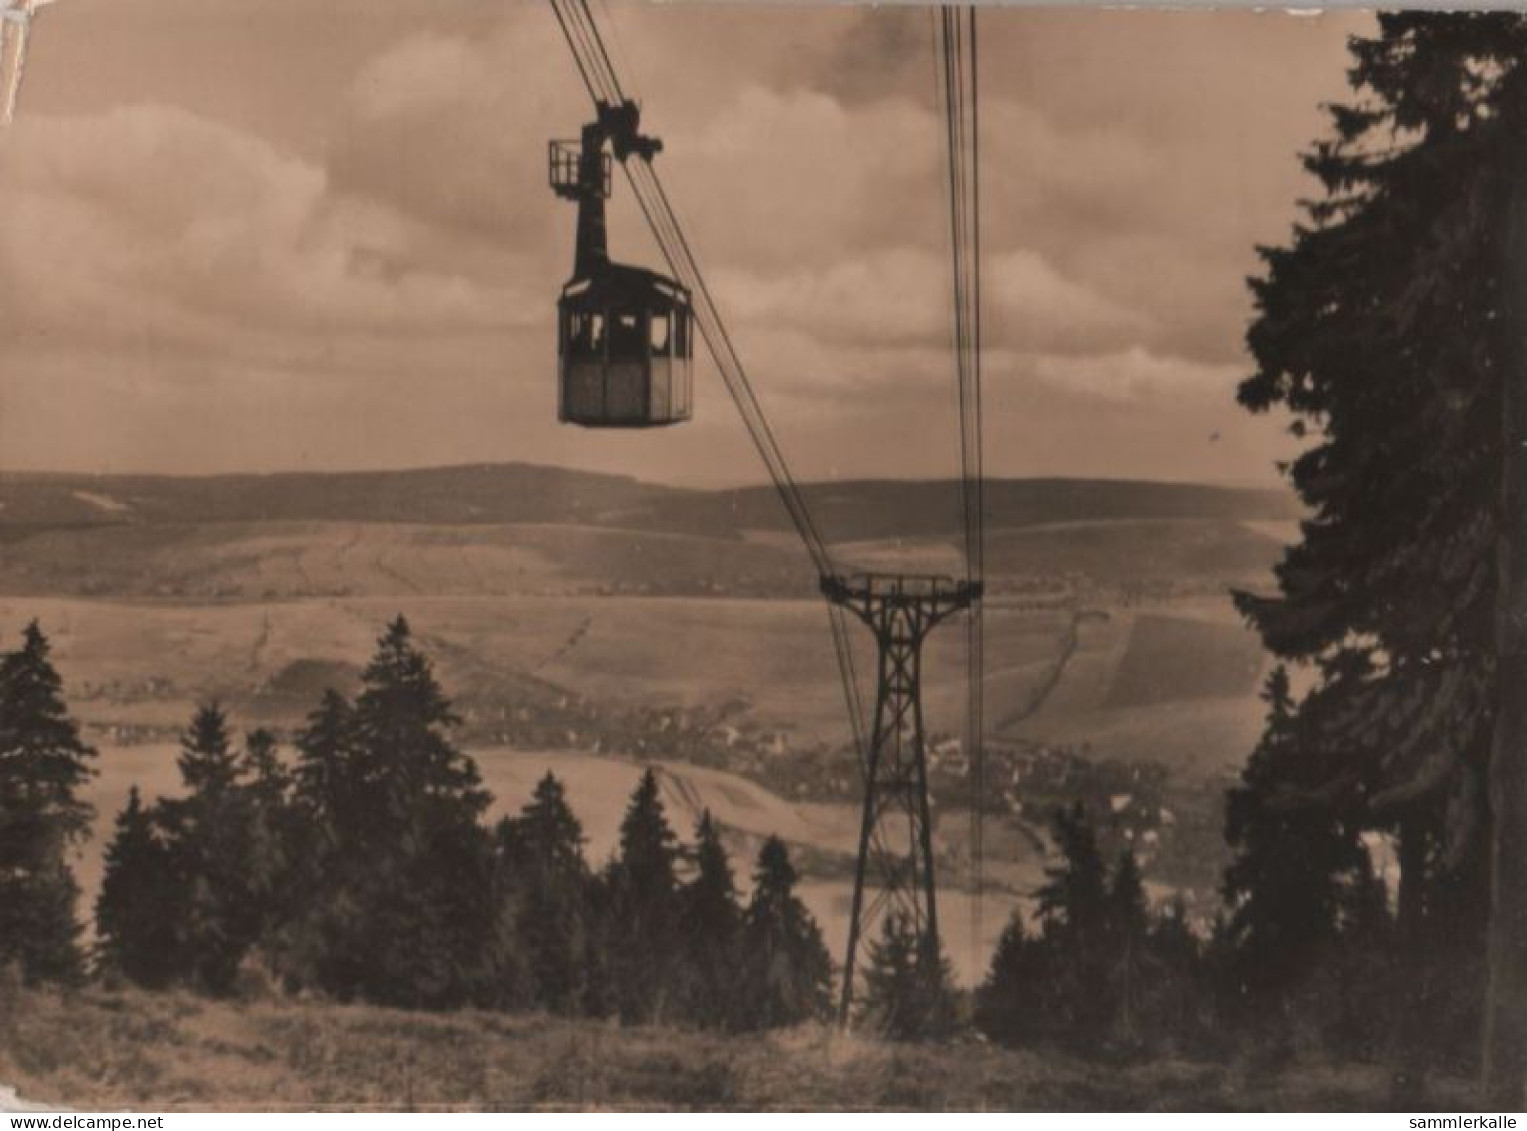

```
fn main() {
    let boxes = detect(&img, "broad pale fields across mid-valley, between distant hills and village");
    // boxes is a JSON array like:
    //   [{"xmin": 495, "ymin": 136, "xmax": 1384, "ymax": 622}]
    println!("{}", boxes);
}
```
[{"xmin": 0, "ymin": 595, "xmax": 1264, "ymax": 769}]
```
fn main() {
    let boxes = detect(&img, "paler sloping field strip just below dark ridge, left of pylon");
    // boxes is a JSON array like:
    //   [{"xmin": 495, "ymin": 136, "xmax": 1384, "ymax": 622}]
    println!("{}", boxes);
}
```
[{"xmin": 0, "ymin": 522, "xmax": 809, "ymax": 601}]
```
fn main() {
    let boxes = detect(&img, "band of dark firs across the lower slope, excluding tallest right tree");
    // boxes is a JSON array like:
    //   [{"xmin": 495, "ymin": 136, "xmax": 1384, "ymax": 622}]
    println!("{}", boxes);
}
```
[{"xmin": 0, "ymin": 617, "xmax": 1478, "ymax": 1092}]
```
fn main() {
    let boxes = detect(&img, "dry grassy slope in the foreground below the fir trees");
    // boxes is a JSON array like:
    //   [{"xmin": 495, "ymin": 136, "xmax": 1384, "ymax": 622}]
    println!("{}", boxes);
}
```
[{"xmin": 0, "ymin": 989, "xmax": 1469, "ymax": 1111}]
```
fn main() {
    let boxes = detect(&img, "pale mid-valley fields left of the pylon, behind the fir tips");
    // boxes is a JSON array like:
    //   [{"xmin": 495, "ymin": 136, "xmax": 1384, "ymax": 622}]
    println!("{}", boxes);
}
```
[{"xmin": 0, "ymin": 595, "xmax": 977, "ymax": 743}]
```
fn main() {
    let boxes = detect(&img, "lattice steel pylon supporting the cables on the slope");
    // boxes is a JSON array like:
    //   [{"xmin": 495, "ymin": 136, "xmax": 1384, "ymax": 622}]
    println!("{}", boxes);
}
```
[{"xmin": 822, "ymin": 574, "xmax": 980, "ymax": 1024}]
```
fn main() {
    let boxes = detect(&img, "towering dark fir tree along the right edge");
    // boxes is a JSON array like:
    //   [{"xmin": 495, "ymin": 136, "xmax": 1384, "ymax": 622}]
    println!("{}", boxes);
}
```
[{"xmin": 1238, "ymin": 12, "xmax": 1527, "ymax": 1104}]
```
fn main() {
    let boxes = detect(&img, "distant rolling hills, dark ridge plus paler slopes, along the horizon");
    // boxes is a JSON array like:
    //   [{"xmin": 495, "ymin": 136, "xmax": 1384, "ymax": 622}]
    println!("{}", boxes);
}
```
[{"xmin": 0, "ymin": 464, "xmax": 1298, "ymax": 600}]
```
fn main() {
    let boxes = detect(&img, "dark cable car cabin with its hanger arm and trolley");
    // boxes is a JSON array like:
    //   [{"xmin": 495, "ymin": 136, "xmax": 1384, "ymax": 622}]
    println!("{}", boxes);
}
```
[{"xmin": 550, "ymin": 101, "xmax": 693, "ymax": 427}]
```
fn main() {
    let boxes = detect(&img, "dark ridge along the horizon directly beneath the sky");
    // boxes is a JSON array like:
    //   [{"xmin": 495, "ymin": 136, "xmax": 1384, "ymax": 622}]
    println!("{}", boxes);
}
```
[{"xmin": 0, "ymin": 464, "xmax": 1299, "ymax": 542}]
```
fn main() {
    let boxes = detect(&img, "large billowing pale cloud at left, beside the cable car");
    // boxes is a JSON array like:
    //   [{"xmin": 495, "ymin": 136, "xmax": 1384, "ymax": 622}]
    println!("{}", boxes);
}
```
[{"xmin": 0, "ymin": 107, "xmax": 540, "ymax": 368}]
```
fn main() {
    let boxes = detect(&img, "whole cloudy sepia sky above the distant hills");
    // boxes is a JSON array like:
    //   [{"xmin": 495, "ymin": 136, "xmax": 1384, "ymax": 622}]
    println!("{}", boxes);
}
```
[{"xmin": 0, "ymin": 0, "xmax": 1370, "ymax": 487}]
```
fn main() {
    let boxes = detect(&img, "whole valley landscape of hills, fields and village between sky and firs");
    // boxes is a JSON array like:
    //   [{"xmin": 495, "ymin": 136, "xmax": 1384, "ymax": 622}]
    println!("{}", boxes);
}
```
[{"xmin": 0, "ymin": 469, "xmax": 1293, "ymax": 984}]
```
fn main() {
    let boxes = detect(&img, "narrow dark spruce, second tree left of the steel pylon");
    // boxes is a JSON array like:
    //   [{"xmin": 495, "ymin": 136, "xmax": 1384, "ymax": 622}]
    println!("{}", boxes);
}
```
[{"xmin": 680, "ymin": 809, "xmax": 742, "ymax": 1026}]
